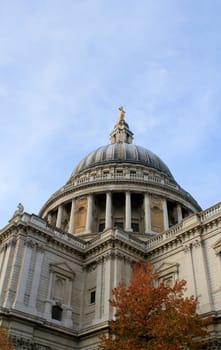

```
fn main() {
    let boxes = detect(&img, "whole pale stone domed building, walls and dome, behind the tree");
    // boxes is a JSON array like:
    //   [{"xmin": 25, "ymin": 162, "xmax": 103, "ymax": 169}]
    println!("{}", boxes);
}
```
[{"xmin": 0, "ymin": 115, "xmax": 221, "ymax": 350}]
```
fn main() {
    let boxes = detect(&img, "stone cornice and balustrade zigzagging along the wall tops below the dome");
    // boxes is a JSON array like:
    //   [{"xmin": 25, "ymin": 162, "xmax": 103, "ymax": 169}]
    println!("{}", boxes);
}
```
[{"xmin": 0, "ymin": 203, "xmax": 221, "ymax": 264}]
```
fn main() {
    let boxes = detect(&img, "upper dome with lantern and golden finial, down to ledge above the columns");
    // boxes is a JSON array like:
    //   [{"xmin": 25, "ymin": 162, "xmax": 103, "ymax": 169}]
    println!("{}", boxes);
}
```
[{"xmin": 40, "ymin": 108, "xmax": 200, "ymax": 217}]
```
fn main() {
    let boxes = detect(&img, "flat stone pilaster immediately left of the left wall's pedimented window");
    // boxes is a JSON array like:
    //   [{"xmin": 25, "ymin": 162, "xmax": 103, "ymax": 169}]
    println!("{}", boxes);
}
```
[{"xmin": 29, "ymin": 247, "xmax": 44, "ymax": 313}]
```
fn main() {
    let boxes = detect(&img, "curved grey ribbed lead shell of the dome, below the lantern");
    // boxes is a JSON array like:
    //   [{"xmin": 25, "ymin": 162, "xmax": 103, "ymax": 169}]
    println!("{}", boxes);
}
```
[{"xmin": 72, "ymin": 143, "xmax": 174, "ymax": 180}]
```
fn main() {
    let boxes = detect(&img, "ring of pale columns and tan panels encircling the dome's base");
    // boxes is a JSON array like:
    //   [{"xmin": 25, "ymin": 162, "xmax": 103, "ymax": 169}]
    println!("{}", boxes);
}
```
[{"xmin": 43, "ymin": 191, "xmax": 191, "ymax": 235}]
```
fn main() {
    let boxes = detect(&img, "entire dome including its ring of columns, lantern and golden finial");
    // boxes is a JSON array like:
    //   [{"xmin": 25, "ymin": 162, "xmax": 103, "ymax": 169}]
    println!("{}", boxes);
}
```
[{"xmin": 40, "ymin": 108, "xmax": 200, "ymax": 239}]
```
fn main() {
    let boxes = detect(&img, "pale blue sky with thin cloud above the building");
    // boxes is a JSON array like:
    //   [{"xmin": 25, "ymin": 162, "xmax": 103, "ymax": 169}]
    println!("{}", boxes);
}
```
[{"xmin": 0, "ymin": 0, "xmax": 221, "ymax": 227}]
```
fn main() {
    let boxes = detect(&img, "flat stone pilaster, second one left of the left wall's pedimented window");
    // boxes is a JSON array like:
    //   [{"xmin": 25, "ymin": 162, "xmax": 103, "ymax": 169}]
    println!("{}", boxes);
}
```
[{"xmin": 13, "ymin": 241, "xmax": 33, "ymax": 311}]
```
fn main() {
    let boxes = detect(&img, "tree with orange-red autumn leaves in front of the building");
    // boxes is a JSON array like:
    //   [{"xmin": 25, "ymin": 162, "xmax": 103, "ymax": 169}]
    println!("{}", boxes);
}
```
[{"xmin": 100, "ymin": 263, "xmax": 208, "ymax": 350}]
